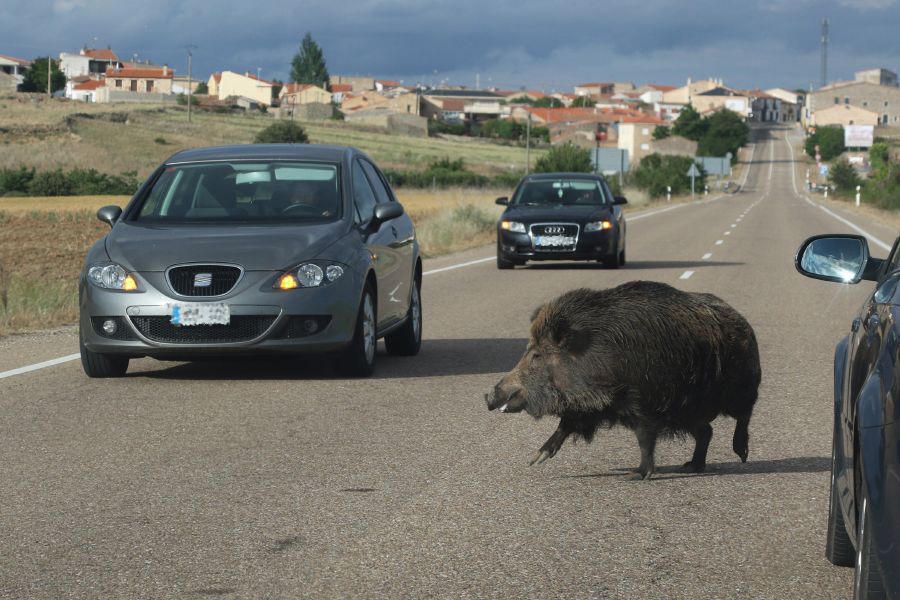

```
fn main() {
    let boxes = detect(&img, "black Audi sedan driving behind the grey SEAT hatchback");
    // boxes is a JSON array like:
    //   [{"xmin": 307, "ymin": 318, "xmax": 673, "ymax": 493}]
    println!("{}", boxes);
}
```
[{"xmin": 497, "ymin": 173, "xmax": 627, "ymax": 269}]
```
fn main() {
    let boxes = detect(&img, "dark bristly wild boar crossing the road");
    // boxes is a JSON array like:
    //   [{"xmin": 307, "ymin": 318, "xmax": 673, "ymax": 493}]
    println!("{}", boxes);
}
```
[{"xmin": 485, "ymin": 281, "xmax": 761, "ymax": 479}]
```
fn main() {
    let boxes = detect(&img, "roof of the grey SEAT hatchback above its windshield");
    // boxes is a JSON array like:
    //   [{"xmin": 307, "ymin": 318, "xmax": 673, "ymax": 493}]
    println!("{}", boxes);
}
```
[{"xmin": 166, "ymin": 144, "xmax": 362, "ymax": 165}]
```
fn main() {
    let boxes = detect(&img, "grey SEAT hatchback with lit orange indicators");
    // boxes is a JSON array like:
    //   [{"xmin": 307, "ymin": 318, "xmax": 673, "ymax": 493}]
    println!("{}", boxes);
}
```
[{"xmin": 79, "ymin": 144, "xmax": 422, "ymax": 377}]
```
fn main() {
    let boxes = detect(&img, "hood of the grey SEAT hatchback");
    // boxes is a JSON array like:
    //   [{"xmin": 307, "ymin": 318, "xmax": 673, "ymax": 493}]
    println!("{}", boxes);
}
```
[{"xmin": 106, "ymin": 221, "xmax": 346, "ymax": 271}]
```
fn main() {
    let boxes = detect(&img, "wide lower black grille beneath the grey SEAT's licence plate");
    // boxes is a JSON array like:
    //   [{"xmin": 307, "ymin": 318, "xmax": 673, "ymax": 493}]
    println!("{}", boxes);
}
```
[{"xmin": 131, "ymin": 315, "xmax": 276, "ymax": 344}]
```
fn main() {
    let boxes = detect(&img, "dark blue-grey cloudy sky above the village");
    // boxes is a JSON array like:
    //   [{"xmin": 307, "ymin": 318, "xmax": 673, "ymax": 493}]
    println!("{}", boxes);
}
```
[{"xmin": 0, "ymin": 0, "xmax": 900, "ymax": 91}]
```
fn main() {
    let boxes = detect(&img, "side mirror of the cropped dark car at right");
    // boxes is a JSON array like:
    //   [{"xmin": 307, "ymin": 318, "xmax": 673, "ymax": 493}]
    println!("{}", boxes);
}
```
[{"xmin": 794, "ymin": 234, "xmax": 884, "ymax": 283}]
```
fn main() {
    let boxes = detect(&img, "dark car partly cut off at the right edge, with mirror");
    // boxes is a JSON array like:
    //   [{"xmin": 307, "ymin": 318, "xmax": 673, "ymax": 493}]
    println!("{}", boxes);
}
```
[{"xmin": 795, "ymin": 235, "xmax": 900, "ymax": 598}]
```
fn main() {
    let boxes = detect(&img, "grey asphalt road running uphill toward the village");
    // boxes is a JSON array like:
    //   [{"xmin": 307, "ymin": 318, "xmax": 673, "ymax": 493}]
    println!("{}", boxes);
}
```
[{"xmin": 0, "ymin": 124, "xmax": 896, "ymax": 598}]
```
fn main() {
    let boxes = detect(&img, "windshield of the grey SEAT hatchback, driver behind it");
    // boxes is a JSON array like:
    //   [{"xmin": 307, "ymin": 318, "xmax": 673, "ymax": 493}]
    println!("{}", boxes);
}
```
[{"xmin": 131, "ymin": 161, "xmax": 341, "ymax": 223}]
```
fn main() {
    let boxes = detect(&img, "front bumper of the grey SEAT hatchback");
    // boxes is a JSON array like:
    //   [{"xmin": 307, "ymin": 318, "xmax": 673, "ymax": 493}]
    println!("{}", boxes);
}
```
[{"xmin": 80, "ymin": 269, "xmax": 362, "ymax": 358}]
